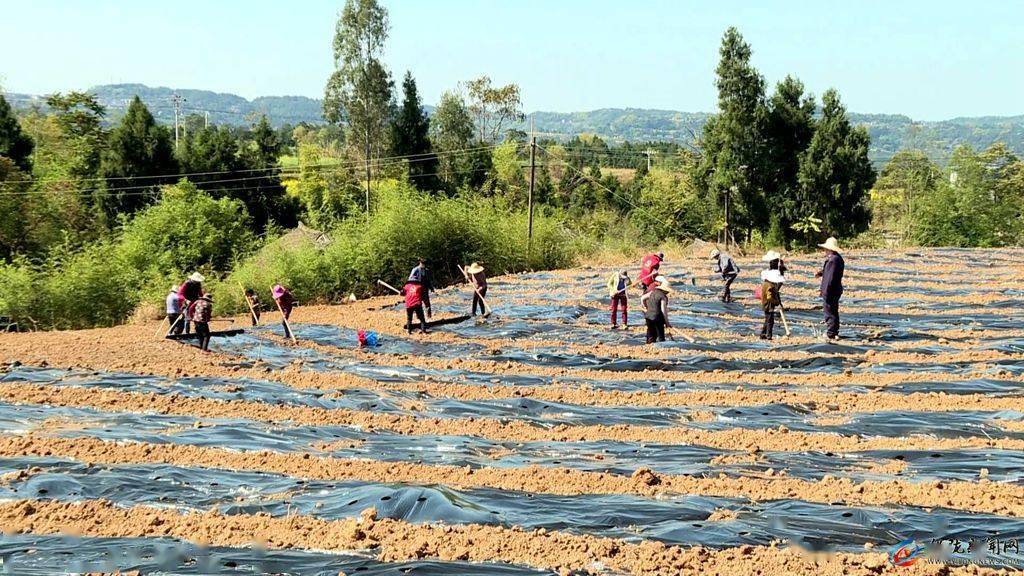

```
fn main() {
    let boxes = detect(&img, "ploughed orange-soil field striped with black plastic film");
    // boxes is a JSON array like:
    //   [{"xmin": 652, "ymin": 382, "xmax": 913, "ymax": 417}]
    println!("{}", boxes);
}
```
[{"xmin": 0, "ymin": 245, "xmax": 1024, "ymax": 575}]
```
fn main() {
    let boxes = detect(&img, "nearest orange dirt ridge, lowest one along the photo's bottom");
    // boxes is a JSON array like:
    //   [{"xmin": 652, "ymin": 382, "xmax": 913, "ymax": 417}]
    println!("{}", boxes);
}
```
[{"xmin": 0, "ymin": 500, "xmax": 997, "ymax": 576}]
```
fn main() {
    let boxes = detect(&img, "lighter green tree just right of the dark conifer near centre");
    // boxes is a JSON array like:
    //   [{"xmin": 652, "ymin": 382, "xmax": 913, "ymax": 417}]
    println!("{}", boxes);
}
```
[{"xmin": 430, "ymin": 88, "xmax": 474, "ymax": 190}]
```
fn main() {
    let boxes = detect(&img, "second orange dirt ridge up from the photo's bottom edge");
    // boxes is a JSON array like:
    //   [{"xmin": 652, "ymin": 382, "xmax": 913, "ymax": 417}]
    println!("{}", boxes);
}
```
[{"xmin": 0, "ymin": 436, "xmax": 1024, "ymax": 517}]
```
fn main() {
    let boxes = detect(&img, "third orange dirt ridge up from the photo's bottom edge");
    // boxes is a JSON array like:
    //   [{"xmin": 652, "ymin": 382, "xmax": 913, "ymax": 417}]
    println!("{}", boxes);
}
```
[{"xmin": 0, "ymin": 383, "xmax": 1024, "ymax": 453}]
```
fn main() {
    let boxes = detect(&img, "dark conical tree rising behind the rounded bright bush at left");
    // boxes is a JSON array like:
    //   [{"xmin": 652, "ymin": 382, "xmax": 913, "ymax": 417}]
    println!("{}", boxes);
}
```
[{"xmin": 100, "ymin": 96, "xmax": 178, "ymax": 217}]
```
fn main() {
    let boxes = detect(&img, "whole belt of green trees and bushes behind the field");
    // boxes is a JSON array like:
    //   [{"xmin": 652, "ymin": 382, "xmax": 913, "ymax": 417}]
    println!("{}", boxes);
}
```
[{"xmin": 0, "ymin": 0, "xmax": 1024, "ymax": 328}]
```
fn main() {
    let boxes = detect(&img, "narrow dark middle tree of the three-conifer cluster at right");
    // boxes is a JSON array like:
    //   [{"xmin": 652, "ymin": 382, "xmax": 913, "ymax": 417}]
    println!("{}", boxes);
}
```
[{"xmin": 764, "ymin": 76, "xmax": 815, "ymax": 243}]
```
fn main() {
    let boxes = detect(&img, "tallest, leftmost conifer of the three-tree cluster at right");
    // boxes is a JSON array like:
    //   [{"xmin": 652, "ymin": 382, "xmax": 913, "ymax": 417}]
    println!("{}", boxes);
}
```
[{"xmin": 698, "ymin": 28, "xmax": 768, "ymax": 237}]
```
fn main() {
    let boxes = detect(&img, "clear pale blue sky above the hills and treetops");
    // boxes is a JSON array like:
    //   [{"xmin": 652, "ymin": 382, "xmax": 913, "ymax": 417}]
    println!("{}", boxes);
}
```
[{"xmin": 0, "ymin": 0, "xmax": 1024, "ymax": 120}]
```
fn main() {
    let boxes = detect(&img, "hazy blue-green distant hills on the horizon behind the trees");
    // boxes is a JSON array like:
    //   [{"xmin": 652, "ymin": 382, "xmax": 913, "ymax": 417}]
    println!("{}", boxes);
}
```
[{"xmin": 7, "ymin": 84, "xmax": 1024, "ymax": 164}]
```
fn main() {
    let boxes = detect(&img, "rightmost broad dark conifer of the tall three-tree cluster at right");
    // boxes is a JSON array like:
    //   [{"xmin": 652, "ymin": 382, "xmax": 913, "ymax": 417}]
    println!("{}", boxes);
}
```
[{"xmin": 792, "ymin": 89, "xmax": 876, "ymax": 237}]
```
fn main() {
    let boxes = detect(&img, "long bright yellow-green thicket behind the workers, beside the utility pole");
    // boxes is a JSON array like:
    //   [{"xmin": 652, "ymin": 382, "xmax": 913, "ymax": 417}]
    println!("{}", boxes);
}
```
[{"xmin": 213, "ymin": 180, "xmax": 577, "ymax": 312}]
